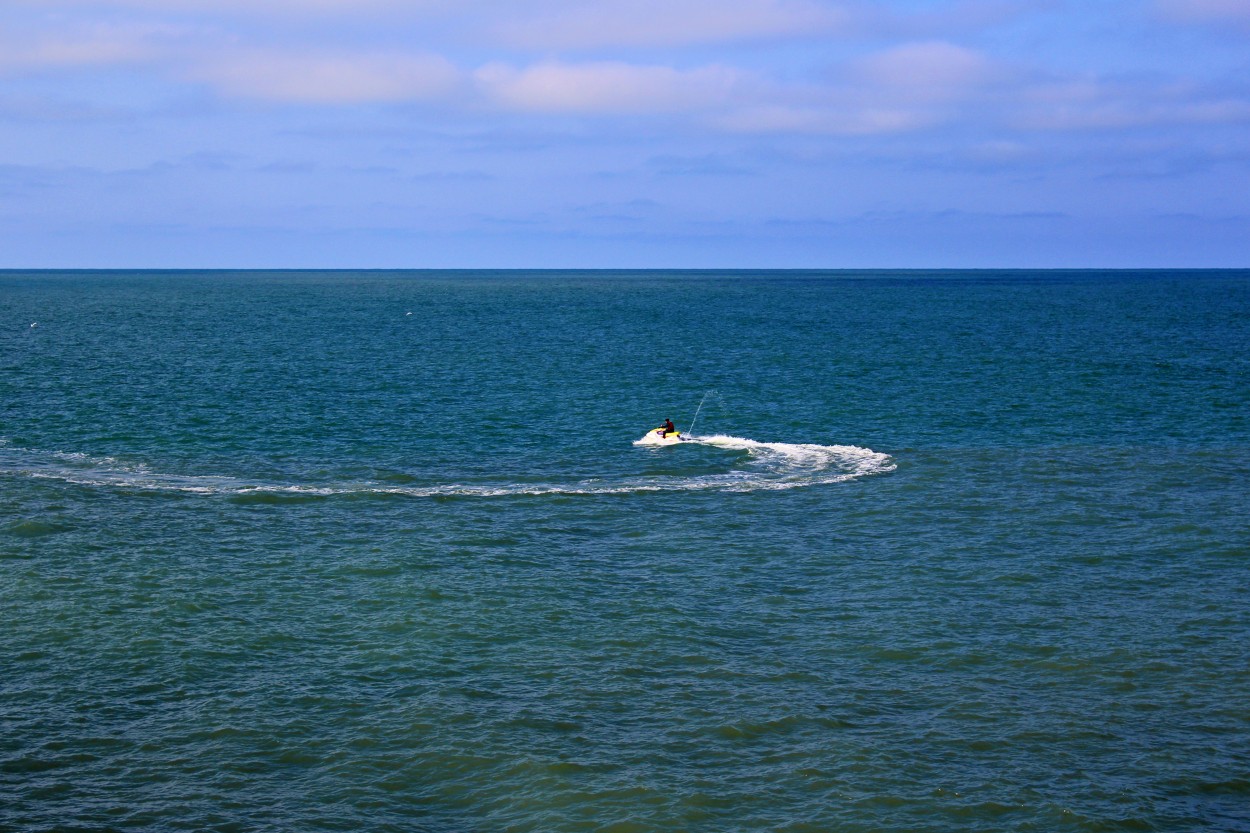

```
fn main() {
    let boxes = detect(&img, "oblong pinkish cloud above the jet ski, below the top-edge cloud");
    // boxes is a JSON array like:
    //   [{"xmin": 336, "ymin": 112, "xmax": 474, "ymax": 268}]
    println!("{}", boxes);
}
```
[{"xmin": 476, "ymin": 61, "xmax": 743, "ymax": 115}]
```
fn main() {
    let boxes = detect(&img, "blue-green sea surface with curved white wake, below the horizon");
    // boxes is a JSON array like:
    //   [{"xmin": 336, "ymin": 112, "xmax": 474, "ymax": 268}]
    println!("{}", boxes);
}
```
[{"xmin": 0, "ymin": 271, "xmax": 1250, "ymax": 833}]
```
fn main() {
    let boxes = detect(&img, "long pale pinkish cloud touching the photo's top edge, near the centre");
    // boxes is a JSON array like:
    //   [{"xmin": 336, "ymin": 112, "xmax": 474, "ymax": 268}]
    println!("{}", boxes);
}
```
[{"xmin": 495, "ymin": 0, "xmax": 848, "ymax": 50}]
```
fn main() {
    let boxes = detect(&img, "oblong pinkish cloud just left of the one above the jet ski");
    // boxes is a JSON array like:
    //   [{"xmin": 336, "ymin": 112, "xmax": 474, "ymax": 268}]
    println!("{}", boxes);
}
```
[{"xmin": 191, "ymin": 50, "xmax": 461, "ymax": 104}]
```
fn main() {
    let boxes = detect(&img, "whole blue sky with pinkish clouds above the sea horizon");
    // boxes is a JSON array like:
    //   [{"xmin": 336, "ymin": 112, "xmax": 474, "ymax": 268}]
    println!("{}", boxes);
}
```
[{"xmin": 0, "ymin": 0, "xmax": 1250, "ymax": 269}]
